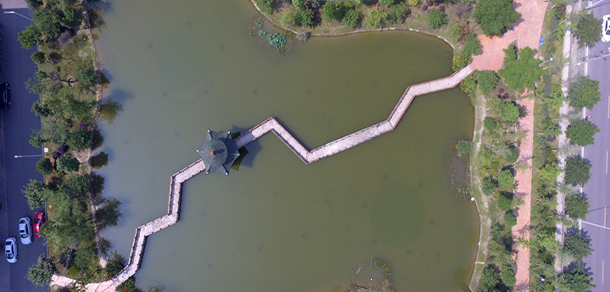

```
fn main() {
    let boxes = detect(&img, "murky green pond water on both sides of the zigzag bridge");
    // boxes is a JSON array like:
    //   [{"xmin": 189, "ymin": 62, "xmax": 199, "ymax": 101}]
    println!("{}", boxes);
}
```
[{"xmin": 96, "ymin": 0, "xmax": 478, "ymax": 292}]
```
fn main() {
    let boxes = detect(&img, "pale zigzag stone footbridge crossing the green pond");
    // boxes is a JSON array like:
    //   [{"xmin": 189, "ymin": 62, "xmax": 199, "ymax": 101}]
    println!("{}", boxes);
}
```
[{"xmin": 51, "ymin": 65, "xmax": 474, "ymax": 292}]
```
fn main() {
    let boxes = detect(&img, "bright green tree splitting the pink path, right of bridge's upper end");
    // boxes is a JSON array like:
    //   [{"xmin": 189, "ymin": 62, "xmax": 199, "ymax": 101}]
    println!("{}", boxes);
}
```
[{"xmin": 498, "ymin": 44, "xmax": 544, "ymax": 93}]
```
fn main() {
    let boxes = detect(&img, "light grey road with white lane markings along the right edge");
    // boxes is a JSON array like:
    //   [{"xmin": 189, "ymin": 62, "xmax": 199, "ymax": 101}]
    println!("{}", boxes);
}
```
[{"xmin": 582, "ymin": 1, "xmax": 610, "ymax": 292}]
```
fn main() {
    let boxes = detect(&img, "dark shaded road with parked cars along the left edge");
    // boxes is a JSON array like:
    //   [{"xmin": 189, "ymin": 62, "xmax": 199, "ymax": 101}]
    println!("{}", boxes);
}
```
[{"xmin": 0, "ymin": 5, "xmax": 49, "ymax": 292}]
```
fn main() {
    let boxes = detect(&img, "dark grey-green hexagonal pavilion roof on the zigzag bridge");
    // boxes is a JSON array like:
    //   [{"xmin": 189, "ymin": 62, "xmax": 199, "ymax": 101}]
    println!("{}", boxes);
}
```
[{"xmin": 197, "ymin": 130, "xmax": 239, "ymax": 175}]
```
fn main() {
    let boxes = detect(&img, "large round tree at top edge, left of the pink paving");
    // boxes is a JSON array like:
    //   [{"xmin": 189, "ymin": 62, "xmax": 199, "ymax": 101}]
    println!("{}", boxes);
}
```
[{"xmin": 473, "ymin": 0, "xmax": 521, "ymax": 36}]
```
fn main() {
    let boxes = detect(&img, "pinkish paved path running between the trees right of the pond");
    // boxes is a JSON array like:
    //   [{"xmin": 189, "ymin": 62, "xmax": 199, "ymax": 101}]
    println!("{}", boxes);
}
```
[{"xmin": 471, "ymin": 0, "xmax": 548, "ymax": 292}]
